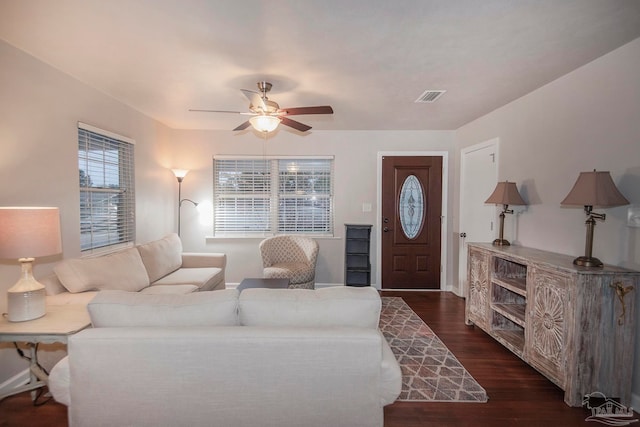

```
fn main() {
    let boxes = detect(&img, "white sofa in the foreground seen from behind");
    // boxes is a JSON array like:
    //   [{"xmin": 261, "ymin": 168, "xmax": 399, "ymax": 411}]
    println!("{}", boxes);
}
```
[{"xmin": 49, "ymin": 287, "xmax": 401, "ymax": 427}]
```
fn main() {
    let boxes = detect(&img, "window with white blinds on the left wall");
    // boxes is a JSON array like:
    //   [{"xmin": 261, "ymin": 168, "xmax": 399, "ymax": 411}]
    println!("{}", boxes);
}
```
[{"xmin": 78, "ymin": 123, "xmax": 135, "ymax": 252}]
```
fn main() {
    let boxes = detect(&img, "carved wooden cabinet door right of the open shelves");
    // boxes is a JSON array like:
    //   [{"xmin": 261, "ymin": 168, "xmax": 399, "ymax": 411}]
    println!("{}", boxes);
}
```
[{"xmin": 526, "ymin": 269, "xmax": 570, "ymax": 388}]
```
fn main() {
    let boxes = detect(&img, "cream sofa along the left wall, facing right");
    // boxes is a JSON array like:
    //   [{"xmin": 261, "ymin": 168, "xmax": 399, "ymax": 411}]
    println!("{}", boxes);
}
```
[{"xmin": 40, "ymin": 233, "xmax": 227, "ymax": 305}]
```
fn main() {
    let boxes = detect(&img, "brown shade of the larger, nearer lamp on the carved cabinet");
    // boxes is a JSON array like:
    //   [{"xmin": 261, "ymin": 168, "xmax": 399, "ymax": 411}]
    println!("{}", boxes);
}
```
[{"xmin": 561, "ymin": 170, "xmax": 629, "ymax": 208}]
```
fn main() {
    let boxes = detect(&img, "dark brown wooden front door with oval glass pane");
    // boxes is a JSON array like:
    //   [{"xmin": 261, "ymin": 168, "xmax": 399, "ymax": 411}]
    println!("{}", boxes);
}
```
[{"xmin": 381, "ymin": 156, "xmax": 442, "ymax": 289}]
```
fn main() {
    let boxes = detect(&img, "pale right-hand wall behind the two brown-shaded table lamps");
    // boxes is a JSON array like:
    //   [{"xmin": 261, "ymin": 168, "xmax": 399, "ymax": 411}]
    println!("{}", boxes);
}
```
[{"xmin": 455, "ymin": 39, "xmax": 640, "ymax": 407}]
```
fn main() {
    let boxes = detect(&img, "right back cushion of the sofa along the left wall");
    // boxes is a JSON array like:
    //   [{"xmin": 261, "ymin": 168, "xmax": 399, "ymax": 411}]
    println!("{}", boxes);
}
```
[{"xmin": 138, "ymin": 233, "xmax": 182, "ymax": 283}]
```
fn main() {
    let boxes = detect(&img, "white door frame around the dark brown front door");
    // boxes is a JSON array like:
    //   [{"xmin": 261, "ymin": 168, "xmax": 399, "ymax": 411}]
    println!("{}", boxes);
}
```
[{"xmin": 375, "ymin": 151, "xmax": 453, "ymax": 291}]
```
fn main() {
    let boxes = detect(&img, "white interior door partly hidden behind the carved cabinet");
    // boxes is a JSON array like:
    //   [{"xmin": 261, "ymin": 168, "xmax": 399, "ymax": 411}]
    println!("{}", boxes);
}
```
[{"xmin": 456, "ymin": 138, "xmax": 499, "ymax": 296}]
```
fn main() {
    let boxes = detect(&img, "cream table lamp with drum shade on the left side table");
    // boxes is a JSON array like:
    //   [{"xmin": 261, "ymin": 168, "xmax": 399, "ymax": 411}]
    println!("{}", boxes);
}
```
[{"xmin": 0, "ymin": 207, "xmax": 62, "ymax": 322}]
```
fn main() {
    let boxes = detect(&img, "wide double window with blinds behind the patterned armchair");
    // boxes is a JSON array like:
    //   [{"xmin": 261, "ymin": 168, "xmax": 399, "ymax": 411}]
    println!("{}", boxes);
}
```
[{"xmin": 213, "ymin": 156, "xmax": 333, "ymax": 236}]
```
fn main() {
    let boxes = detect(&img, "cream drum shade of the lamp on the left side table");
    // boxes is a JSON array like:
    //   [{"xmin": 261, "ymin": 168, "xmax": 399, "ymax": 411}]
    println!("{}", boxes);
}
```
[{"xmin": 0, "ymin": 207, "xmax": 62, "ymax": 259}]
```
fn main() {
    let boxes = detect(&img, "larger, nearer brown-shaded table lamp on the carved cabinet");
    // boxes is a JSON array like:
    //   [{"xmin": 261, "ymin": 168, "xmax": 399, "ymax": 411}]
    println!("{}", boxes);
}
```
[{"xmin": 561, "ymin": 169, "xmax": 629, "ymax": 267}]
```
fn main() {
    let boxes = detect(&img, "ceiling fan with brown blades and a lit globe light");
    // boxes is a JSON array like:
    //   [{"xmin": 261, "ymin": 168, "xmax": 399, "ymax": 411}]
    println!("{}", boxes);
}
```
[{"xmin": 189, "ymin": 81, "xmax": 333, "ymax": 132}]
